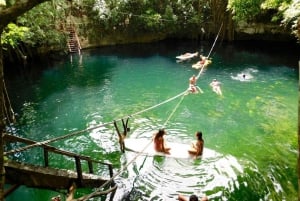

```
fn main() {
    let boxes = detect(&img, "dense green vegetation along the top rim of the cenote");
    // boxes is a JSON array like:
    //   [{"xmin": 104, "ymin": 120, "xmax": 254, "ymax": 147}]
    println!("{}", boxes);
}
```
[{"xmin": 0, "ymin": 0, "xmax": 300, "ymax": 61}]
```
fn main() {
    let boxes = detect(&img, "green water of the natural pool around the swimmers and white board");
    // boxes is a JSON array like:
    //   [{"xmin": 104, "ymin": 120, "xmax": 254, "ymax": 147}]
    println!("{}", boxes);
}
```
[{"xmin": 7, "ymin": 42, "xmax": 299, "ymax": 201}]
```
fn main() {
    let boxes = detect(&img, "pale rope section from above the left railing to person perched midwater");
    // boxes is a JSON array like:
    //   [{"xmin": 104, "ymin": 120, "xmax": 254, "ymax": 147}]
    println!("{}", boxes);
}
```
[{"xmin": 3, "ymin": 88, "xmax": 186, "ymax": 155}]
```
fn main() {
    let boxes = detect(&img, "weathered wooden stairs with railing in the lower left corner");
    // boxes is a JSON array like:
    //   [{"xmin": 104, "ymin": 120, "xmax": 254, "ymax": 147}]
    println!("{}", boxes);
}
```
[{"xmin": 3, "ymin": 134, "xmax": 117, "ymax": 201}]
